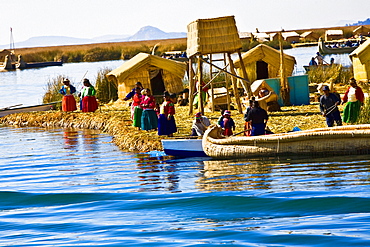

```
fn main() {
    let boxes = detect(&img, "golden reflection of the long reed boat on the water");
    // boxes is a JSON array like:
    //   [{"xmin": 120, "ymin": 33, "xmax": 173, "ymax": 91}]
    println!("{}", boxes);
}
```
[{"xmin": 196, "ymin": 156, "xmax": 370, "ymax": 191}]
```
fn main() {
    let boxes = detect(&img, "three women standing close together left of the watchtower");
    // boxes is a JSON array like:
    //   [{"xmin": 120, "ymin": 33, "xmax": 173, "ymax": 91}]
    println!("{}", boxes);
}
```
[{"xmin": 124, "ymin": 82, "xmax": 177, "ymax": 136}]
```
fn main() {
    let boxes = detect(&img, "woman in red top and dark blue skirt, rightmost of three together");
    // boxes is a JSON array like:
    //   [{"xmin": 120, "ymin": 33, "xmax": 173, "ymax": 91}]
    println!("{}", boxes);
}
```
[{"xmin": 158, "ymin": 91, "xmax": 177, "ymax": 136}]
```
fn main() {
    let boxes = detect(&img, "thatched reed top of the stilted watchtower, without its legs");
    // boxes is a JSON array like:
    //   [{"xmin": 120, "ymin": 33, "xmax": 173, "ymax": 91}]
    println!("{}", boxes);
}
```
[{"xmin": 186, "ymin": 16, "xmax": 242, "ymax": 57}]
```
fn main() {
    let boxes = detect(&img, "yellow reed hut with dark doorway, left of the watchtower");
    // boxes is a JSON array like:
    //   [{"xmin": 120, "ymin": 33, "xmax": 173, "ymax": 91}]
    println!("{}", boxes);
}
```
[{"xmin": 107, "ymin": 53, "xmax": 187, "ymax": 99}]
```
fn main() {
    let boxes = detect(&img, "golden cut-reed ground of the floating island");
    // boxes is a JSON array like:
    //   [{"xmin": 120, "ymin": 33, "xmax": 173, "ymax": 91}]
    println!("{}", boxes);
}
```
[{"xmin": 0, "ymin": 104, "xmax": 338, "ymax": 152}]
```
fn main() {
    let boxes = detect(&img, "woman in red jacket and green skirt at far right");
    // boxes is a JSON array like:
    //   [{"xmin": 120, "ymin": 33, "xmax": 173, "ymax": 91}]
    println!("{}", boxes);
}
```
[{"xmin": 343, "ymin": 78, "xmax": 365, "ymax": 123}]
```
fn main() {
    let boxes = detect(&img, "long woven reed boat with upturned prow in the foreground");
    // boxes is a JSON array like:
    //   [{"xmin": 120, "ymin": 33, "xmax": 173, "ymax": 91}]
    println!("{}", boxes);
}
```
[{"xmin": 203, "ymin": 124, "xmax": 370, "ymax": 158}]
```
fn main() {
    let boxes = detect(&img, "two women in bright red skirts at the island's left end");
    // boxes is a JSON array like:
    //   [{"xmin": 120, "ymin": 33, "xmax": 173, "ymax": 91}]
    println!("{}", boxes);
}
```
[{"xmin": 59, "ymin": 78, "xmax": 98, "ymax": 112}]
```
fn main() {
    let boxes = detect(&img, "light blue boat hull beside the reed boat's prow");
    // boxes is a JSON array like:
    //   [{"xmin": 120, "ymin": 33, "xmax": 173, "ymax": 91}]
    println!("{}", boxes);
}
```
[{"xmin": 162, "ymin": 139, "xmax": 207, "ymax": 157}]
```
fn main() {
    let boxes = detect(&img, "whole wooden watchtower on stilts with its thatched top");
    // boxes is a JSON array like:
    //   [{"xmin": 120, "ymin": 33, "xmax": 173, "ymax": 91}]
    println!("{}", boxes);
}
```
[{"xmin": 187, "ymin": 16, "xmax": 251, "ymax": 114}]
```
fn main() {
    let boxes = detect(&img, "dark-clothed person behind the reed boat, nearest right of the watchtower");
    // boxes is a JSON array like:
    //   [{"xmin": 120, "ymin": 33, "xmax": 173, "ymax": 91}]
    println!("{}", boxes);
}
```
[{"xmin": 245, "ymin": 101, "xmax": 268, "ymax": 136}]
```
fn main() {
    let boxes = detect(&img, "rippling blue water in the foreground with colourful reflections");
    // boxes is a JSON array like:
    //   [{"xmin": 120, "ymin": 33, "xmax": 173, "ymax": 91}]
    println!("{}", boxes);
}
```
[{"xmin": 0, "ymin": 127, "xmax": 370, "ymax": 246}]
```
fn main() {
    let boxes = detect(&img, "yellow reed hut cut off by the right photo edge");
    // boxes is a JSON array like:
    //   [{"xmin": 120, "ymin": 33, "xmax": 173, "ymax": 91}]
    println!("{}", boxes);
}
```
[{"xmin": 349, "ymin": 39, "xmax": 370, "ymax": 82}]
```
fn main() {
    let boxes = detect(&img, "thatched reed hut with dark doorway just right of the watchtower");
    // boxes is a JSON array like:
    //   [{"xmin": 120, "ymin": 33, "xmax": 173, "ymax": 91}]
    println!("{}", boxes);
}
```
[{"xmin": 234, "ymin": 44, "xmax": 296, "ymax": 82}]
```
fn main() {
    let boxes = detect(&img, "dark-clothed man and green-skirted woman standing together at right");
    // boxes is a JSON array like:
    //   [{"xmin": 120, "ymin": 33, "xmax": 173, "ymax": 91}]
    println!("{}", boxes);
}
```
[{"xmin": 320, "ymin": 78, "xmax": 365, "ymax": 127}]
